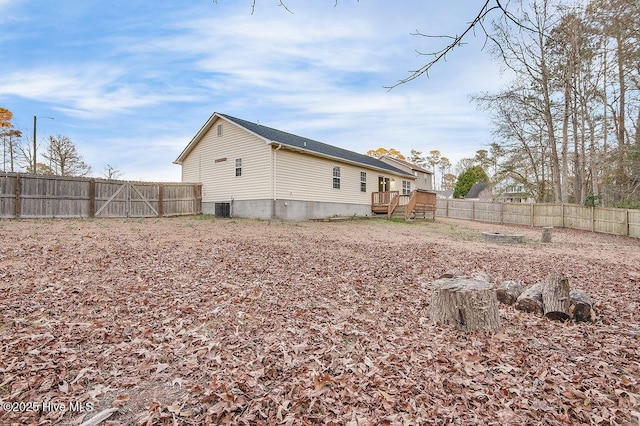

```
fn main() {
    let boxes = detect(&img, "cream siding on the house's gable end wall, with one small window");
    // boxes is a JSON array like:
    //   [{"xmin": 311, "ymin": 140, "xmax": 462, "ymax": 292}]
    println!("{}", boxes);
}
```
[{"xmin": 182, "ymin": 119, "xmax": 272, "ymax": 202}]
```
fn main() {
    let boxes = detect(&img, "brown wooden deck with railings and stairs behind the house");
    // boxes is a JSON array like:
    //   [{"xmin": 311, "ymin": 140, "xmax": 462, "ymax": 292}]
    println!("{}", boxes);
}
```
[{"xmin": 371, "ymin": 189, "xmax": 436, "ymax": 220}]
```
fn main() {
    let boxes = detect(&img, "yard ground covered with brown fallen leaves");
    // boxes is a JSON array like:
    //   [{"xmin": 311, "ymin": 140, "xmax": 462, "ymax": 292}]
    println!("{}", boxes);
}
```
[{"xmin": 0, "ymin": 217, "xmax": 640, "ymax": 426}]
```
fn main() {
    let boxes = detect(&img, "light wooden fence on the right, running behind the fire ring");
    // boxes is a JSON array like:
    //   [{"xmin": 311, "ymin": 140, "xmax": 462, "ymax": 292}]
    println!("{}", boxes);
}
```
[{"xmin": 436, "ymin": 199, "xmax": 640, "ymax": 238}]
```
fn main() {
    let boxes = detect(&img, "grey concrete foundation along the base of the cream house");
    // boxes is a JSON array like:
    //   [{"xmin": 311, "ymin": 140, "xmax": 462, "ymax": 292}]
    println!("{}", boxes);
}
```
[{"xmin": 202, "ymin": 200, "xmax": 371, "ymax": 221}]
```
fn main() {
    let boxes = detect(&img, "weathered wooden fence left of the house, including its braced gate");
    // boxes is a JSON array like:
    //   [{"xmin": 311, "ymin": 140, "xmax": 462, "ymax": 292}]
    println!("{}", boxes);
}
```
[{"xmin": 0, "ymin": 173, "xmax": 202, "ymax": 218}]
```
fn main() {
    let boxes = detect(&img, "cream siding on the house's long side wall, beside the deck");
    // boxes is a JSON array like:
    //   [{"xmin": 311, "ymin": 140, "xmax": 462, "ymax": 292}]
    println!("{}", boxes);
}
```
[{"xmin": 275, "ymin": 148, "xmax": 400, "ymax": 204}]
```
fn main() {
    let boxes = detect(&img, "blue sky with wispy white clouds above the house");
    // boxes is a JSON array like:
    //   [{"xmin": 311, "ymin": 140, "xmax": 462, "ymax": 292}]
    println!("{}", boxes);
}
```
[{"xmin": 0, "ymin": 0, "xmax": 504, "ymax": 181}]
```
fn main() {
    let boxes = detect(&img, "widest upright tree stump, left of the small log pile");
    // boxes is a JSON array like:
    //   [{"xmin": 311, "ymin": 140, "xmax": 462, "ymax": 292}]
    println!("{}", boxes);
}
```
[{"xmin": 430, "ymin": 277, "xmax": 500, "ymax": 331}]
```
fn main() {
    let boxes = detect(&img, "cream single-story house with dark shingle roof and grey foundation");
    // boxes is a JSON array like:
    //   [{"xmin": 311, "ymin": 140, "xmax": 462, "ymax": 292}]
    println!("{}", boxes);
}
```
[{"xmin": 174, "ymin": 113, "xmax": 416, "ymax": 220}]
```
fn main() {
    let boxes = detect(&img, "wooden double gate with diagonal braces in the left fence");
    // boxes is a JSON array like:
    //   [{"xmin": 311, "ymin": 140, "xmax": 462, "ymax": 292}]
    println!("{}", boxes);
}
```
[{"xmin": 95, "ymin": 182, "xmax": 161, "ymax": 217}]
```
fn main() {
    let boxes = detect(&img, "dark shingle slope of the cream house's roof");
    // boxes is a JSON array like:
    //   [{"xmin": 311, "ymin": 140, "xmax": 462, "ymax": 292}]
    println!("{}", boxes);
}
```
[{"xmin": 218, "ymin": 114, "xmax": 413, "ymax": 177}]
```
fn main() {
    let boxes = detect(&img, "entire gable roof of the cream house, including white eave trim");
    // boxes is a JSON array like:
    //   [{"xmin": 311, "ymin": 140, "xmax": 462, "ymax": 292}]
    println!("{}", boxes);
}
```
[{"xmin": 174, "ymin": 112, "xmax": 415, "ymax": 179}]
